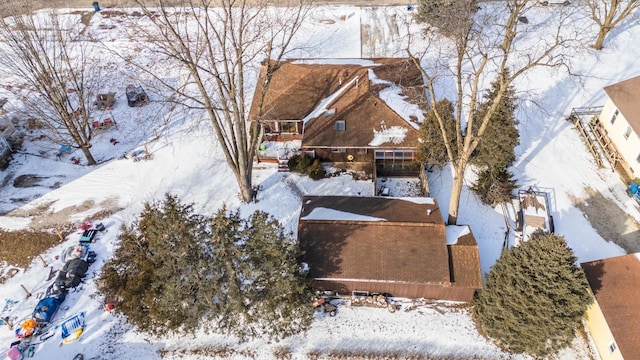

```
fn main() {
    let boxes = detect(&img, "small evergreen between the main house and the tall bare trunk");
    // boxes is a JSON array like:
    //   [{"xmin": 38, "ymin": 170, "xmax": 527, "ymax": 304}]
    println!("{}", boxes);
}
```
[{"xmin": 418, "ymin": 99, "xmax": 456, "ymax": 168}]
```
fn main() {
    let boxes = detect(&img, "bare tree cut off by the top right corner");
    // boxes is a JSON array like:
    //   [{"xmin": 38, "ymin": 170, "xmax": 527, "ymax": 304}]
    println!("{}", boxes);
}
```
[{"xmin": 585, "ymin": 0, "xmax": 640, "ymax": 50}]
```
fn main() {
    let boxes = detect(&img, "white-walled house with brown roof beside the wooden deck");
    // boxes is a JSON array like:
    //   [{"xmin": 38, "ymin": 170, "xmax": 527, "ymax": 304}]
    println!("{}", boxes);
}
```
[{"xmin": 599, "ymin": 76, "xmax": 640, "ymax": 183}]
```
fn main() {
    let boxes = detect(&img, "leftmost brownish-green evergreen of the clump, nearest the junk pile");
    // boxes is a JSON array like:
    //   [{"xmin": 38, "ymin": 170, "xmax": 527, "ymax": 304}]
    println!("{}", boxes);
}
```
[{"xmin": 98, "ymin": 195, "xmax": 211, "ymax": 333}]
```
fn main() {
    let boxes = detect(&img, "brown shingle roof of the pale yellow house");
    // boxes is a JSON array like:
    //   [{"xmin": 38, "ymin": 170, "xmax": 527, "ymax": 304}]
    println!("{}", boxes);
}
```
[{"xmin": 581, "ymin": 253, "xmax": 640, "ymax": 358}]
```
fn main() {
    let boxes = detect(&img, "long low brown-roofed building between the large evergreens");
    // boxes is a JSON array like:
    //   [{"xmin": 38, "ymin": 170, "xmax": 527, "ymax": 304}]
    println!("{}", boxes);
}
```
[{"xmin": 298, "ymin": 196, "xmax": 482, "ymax": 301}]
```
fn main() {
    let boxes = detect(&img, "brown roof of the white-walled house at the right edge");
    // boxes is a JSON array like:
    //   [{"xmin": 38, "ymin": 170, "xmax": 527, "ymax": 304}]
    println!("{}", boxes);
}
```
[{"xmin": 604, "ymin": 76, "xmax": 640, "ymax": 136}]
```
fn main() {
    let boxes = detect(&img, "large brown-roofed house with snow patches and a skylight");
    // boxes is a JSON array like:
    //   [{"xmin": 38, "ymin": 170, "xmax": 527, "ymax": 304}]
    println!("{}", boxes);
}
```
[{"xmin": 249, "ymin": 58, "xmax": 423, "ymax": 176}]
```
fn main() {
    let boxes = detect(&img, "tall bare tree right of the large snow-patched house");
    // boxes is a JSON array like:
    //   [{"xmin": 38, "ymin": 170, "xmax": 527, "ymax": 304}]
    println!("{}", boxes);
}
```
[{"xmin": 407, "ymin": 0, "xmax": 578, "ymax": 224}]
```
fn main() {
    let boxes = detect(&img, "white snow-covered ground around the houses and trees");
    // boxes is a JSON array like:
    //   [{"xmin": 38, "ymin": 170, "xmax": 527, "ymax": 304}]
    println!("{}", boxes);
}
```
[{"xmin": 0, "ymin": 6, "xmax": 640, "ymax": 359}]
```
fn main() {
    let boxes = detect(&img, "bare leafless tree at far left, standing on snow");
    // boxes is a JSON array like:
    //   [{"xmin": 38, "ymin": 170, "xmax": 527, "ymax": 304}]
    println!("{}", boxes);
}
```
[{"xmin": 0, "ymin": 1, "xmax": 99, "ymax": 165}]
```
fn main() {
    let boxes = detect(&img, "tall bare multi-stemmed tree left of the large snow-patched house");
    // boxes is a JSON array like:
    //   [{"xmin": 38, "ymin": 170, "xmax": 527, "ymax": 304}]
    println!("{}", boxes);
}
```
[{"xmin": 125, "ymin": 0, "xmax": 309, "ymax": 201}]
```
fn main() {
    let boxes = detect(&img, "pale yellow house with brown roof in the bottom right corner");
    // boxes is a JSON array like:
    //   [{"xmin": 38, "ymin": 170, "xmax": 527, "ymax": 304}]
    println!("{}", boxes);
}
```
[{"xmin": 581, "ymin": 253, "xmax": 640, "ymax": 360}]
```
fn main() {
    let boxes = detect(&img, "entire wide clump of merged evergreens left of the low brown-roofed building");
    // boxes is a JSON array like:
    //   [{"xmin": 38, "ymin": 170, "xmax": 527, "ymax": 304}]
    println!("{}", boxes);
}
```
[{"xmin": 99, "ymin": 195, "xmax": 313, "ymax": 339}]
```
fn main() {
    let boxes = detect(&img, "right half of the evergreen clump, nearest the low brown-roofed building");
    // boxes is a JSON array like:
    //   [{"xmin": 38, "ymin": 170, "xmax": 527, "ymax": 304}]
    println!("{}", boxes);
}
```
[{"xmin": 206, "ymin": 209, "xmax": 313, "ymax": 339}]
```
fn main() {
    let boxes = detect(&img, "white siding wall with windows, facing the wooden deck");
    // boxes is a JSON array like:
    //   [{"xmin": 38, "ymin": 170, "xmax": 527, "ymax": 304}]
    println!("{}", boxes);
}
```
[{"xmin": 600, "ymin": 98, "xmax": 640, "ymax": 177}]
